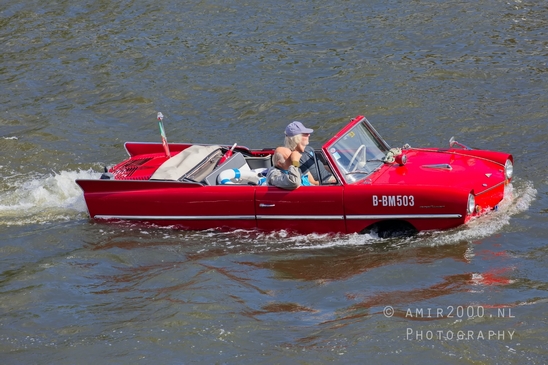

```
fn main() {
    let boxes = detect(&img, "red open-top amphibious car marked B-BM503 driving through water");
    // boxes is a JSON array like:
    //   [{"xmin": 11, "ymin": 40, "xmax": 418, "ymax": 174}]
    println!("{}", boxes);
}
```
[{"xmin": 76, "ymin": 116, "xmax": 513, "ymax": 236}]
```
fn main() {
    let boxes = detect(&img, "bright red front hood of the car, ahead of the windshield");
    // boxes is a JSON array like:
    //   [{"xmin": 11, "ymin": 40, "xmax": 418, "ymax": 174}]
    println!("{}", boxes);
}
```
[{"xmin": 366, "ymin": 149, "xmax": 509, "ymax": 194}]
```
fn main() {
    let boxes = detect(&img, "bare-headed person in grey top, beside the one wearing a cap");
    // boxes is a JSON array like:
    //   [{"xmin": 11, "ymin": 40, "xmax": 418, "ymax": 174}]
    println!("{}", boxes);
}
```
[{"xmin": 266, "ymin": 147, "xmax": 314, "ymax": 190}]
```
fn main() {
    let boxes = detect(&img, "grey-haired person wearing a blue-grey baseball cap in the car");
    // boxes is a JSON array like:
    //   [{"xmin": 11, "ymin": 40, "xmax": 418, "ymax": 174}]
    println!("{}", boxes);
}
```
[{"xmin": 284, "ymin": 121, "xmax": 336, "ymax": 185}]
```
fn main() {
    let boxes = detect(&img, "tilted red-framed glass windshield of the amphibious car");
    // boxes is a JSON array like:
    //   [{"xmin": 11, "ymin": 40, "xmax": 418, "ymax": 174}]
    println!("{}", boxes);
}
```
[{"xmin": 328, "ymin": 121, "xmax": 390, "ymax": 183}]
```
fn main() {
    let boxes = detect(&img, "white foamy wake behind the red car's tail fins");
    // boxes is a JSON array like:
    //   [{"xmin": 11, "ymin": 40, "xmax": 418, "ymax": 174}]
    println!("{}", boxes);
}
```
[{"xmin": 0, "ymin": 169, "xmax": 100, "ymax": 225}]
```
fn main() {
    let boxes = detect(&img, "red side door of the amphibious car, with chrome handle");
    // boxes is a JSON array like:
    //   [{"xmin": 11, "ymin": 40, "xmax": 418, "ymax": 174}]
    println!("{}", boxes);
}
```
[{"xmin": 255, "ymin": 185, "xmax": 346, "ymax": 234}]
